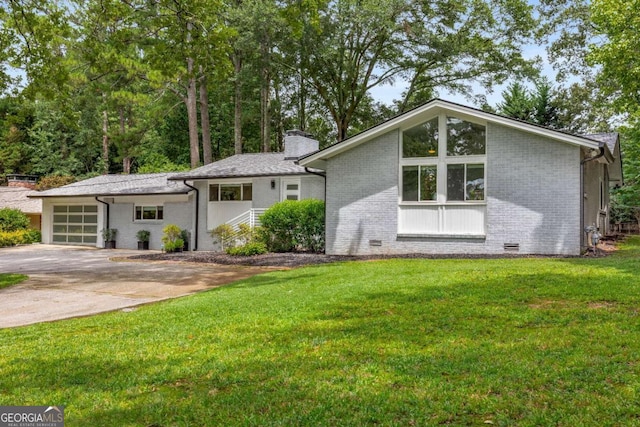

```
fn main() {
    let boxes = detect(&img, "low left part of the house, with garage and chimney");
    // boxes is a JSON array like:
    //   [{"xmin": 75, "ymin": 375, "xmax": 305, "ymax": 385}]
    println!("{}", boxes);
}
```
[{"xmin": 31, "ymin": 132, "xmax": 324, "ymax": 250}]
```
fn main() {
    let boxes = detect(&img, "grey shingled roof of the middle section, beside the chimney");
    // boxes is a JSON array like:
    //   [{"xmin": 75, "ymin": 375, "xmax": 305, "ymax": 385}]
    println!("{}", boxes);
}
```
[{"xmin": 169, "ymin": 153, "xmax": 319, "ymax": 180}]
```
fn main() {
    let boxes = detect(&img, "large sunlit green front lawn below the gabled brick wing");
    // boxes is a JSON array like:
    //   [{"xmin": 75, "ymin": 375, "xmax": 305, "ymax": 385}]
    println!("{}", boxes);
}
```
[{"xmin": 0, "ymin": 238, "xmax": 640, "ymax": 426}]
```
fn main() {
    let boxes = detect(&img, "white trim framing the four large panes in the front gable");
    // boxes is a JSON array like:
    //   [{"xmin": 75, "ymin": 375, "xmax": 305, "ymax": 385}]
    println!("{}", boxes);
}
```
[{"xmin": 398, "ymin": 111, "xmax": 488, "ymax": 206}]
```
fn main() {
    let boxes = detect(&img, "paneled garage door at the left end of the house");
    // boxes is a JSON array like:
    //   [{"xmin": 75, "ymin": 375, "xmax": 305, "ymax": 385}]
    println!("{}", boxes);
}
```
[{"xmin": 53, "ymin": 205, "xmax": 98, "ymax": 245}]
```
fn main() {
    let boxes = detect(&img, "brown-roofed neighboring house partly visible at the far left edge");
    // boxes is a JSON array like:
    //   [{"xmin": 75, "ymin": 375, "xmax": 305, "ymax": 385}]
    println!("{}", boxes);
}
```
[{"xmin": 0, "ymin": 175, "xmax": 42, "ymax": 230}]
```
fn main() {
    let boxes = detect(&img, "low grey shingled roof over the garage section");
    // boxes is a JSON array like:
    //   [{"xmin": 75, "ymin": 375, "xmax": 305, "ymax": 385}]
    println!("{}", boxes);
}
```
[{"xmin": 29, "ymin": 173, "xmax": 192, "ymax": 198}]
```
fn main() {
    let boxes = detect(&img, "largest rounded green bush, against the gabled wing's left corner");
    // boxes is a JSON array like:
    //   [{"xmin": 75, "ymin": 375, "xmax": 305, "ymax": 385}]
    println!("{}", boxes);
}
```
[{"xmin": 260, "ymin": 199, "xmax": 324, "ymax": 252}]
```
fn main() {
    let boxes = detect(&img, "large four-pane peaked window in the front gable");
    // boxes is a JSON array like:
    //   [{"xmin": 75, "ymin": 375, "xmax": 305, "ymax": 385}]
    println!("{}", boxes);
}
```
[{"xmin": 400, "ymin": 114, "xmax": 486, "ymax": 203}]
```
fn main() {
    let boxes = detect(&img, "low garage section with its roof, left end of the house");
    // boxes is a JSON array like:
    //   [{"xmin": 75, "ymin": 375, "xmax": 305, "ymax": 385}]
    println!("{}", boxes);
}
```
[{"xmin": 29, "ymin": 173, "xmax": 192, "ymax": 250}]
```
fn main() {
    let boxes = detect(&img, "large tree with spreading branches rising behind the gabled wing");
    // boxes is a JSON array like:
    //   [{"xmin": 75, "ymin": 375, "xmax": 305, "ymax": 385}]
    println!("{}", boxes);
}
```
[{"xmin": 282, "ymin": 0, "xmax": 535, "ymax": 140}]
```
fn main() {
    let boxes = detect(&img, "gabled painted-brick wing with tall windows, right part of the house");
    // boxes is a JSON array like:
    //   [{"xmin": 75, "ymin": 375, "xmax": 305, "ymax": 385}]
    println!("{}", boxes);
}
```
[{"xmin": 298, "ymin": 99, "xmax": 622, "ymax": 255}]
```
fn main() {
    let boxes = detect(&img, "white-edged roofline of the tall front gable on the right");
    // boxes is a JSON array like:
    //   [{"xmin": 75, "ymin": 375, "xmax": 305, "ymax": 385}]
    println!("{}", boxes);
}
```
[{"xmin": 298, "ymin": 98, "xmax": 599, "ymax": 169}]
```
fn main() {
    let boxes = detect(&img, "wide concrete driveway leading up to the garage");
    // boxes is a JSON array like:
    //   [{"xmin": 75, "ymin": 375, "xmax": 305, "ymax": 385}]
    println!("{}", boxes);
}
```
[{"xmin": 0, "ymin": 245, "xmax": 273, "ymax": 328}]
